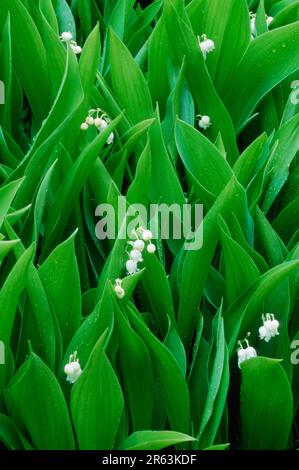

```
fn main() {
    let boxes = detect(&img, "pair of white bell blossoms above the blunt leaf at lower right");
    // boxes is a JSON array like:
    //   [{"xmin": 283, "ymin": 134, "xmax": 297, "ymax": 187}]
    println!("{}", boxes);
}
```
[{"xmin": 237, "ymin": 313, "xmax": 279, "ymax": 367}]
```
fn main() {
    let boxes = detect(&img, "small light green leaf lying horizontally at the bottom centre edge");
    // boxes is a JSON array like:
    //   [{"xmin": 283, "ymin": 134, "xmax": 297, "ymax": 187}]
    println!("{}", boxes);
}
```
[{"xmin": 119, "ymin": 431, "xmax": 195, "ymax": 451}]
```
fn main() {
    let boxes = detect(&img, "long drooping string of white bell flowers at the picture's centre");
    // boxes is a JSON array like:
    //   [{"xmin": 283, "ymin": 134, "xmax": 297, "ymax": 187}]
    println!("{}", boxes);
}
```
[{"xmin": 114, "ymin": 227, "xmax": 156, "ymax": 299}]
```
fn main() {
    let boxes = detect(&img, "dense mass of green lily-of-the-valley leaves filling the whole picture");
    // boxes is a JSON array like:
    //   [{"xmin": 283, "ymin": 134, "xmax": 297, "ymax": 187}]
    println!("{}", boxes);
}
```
[{"xmin": 0, "ymin": 0, "xmax": 299, "ymax": 450}]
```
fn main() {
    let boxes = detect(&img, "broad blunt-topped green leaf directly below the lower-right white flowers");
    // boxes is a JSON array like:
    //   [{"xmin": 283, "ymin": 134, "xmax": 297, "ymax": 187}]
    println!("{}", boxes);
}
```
[{"xmin": 241, "ymin": 357, "xmax": 293, "ymax": 450}]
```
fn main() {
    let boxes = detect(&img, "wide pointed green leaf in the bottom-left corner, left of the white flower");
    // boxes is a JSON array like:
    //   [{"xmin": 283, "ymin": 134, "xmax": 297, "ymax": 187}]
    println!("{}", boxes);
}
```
[{"xmin": 6, "ymin": 353, "xmax": 75, "ymax": 450}]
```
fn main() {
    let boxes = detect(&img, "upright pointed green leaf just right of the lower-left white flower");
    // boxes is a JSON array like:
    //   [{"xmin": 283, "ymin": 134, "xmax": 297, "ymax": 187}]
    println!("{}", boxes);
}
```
[{"xmin": 71, "ymin": 333, "xmax": 124, "ymax": 450}]
